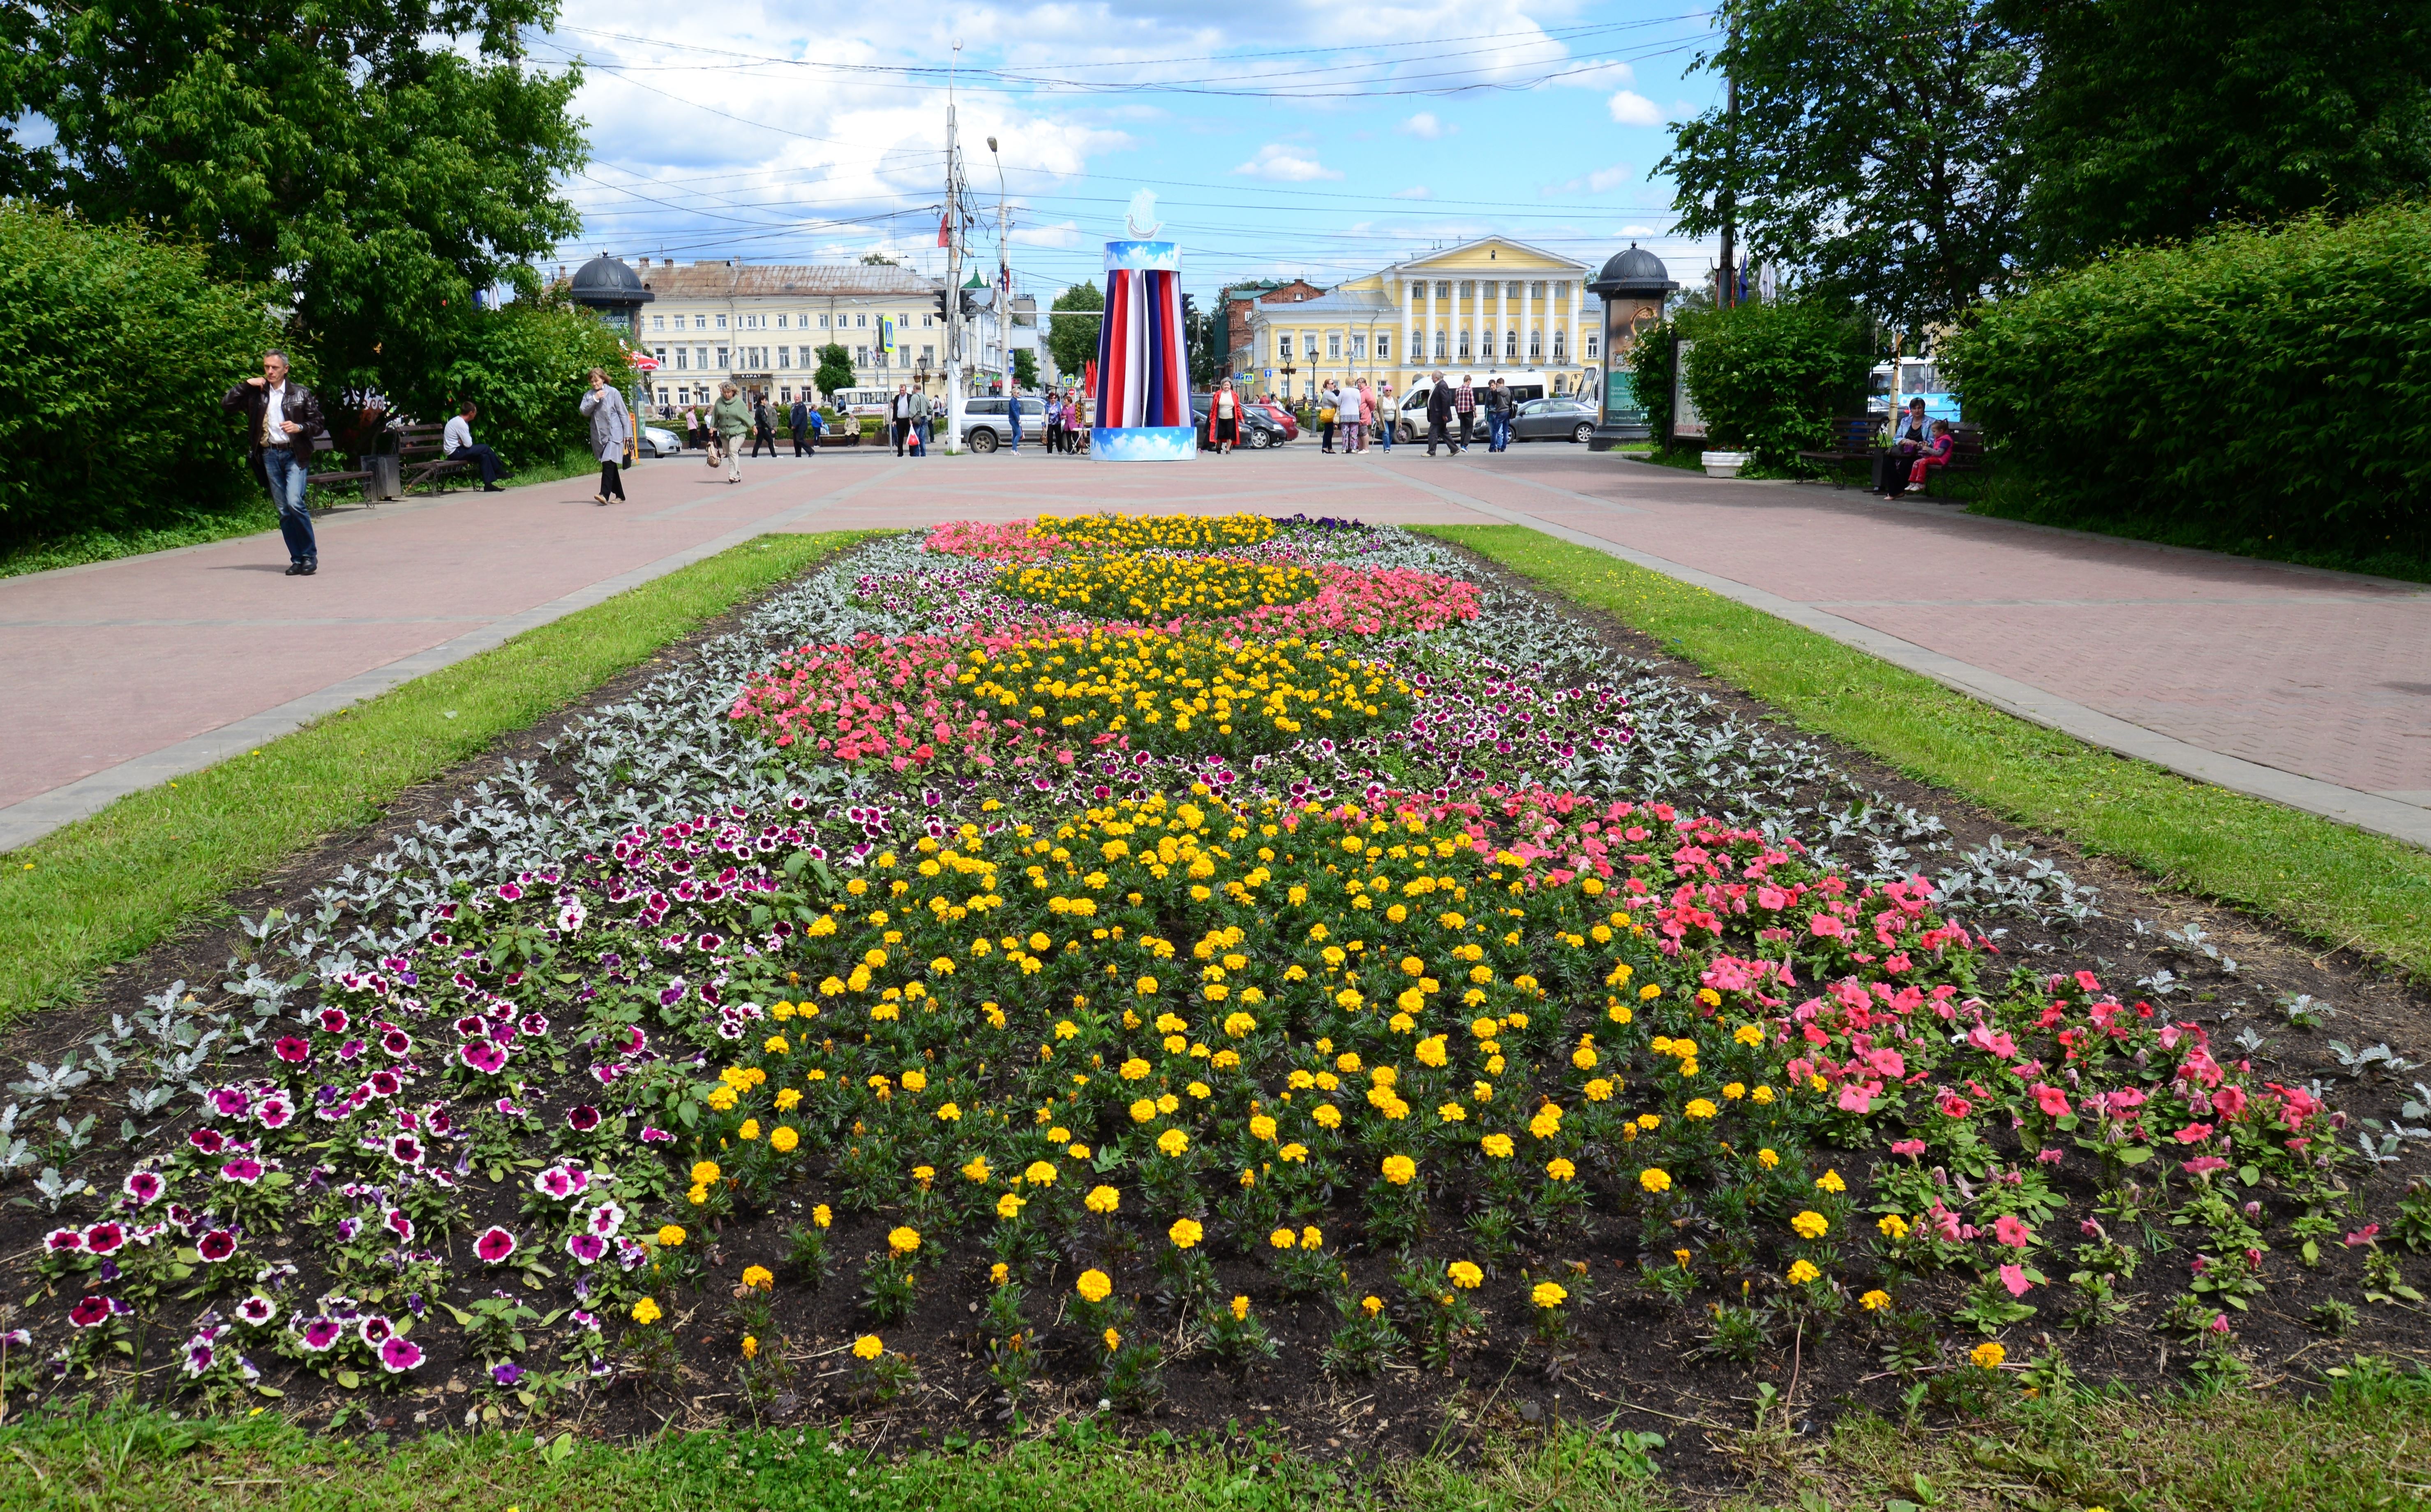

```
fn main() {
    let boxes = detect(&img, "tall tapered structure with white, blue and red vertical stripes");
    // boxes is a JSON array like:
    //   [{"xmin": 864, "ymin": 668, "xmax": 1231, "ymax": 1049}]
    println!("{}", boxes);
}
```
[{"xmin": 1089, "ymin": 189, "xmax": 1198, "ymax": 462}]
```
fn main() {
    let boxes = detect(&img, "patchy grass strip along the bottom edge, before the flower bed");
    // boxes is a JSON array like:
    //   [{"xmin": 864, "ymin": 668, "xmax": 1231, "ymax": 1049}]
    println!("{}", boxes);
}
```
[{"xmin": 0, "ymin": 1361, "xmax": 2431, "ymax": 1512}]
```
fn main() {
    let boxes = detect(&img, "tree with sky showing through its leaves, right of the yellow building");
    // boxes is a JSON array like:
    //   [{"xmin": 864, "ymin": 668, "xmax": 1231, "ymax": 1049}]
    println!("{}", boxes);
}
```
[{"xmin": 1655, "ymin": 0, "xmax": 2027, "ymax": 331}]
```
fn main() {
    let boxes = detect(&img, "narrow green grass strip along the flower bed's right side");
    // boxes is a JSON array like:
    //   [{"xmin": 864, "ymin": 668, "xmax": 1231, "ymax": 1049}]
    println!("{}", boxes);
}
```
[{"xmin": 1417, "ymin": 525, "xmax": 2431, "ymax": 982}]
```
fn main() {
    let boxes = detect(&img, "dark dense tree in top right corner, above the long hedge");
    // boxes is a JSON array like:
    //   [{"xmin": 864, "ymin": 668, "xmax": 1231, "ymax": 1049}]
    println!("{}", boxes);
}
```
[{"xmin": 2018, "ymin": 0, "xmax": 2431, "ymax": 265}]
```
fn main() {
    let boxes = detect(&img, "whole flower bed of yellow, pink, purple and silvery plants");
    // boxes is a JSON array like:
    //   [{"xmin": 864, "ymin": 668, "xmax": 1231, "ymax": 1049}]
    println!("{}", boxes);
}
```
[{"xmin": 0, "ymin": 518, "xmax": 2431, "ymax": 1449}]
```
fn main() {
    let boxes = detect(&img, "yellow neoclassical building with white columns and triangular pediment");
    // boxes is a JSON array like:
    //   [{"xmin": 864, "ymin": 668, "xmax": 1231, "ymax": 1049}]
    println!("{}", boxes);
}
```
[{"xmin": 1233, "ymin": 236, "xmax": 1605, "ymax": 399}]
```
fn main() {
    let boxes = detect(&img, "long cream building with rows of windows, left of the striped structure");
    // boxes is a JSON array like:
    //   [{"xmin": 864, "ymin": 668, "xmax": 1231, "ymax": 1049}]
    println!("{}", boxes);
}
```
[{"xmin": 635, "ymin": 258, "xmax": 946, "ymax": 406}]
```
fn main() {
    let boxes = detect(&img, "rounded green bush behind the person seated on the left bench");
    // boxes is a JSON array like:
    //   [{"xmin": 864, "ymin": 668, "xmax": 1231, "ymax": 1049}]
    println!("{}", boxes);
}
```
[{"xmin": 432, "ymin": 292, "xmax": 625, "ymax": 467}]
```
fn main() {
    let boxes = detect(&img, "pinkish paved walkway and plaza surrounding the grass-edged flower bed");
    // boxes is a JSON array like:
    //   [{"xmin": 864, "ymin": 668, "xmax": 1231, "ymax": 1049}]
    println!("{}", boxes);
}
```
[{"xmin": 0, "ymin": 443, "xmax": 2431, "ymax": 848}]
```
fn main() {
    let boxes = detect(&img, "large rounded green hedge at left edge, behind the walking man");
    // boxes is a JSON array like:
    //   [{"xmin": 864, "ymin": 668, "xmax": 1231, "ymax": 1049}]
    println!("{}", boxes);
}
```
[{"xmin": 0, "ymin": 207, "xmax": 272, "ymax": 542}]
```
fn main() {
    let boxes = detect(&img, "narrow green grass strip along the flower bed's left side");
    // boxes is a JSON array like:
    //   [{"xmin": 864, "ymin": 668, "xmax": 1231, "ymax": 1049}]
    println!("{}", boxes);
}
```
[{"xmin": 0, "ymin": 532, "xmax": 858, "ymax": 1023}]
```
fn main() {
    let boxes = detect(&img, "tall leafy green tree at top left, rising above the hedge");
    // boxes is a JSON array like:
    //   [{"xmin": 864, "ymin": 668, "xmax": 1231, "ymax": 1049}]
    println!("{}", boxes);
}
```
[{"xmin": 14, "ymin": 0, "xmax": 588, "ymax": 418}]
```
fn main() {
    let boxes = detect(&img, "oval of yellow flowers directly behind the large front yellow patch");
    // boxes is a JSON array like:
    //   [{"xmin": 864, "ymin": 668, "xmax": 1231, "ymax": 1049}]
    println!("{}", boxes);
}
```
[{"xmin": 956, "ymin": 629, "xmax": 1424, "ymax": 751}]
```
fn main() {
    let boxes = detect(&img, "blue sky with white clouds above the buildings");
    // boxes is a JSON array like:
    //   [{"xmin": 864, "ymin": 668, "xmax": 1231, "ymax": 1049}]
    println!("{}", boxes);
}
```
[{"xmin": 532, "ymin": 0, "xmax": 1719, "ymax": 294}]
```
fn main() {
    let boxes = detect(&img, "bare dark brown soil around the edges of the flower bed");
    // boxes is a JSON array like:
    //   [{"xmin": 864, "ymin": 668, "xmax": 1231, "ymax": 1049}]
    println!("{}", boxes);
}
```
[{"xmin": 0, "ymin": 537, "xmax": 2431, "ymax": 1493}]
